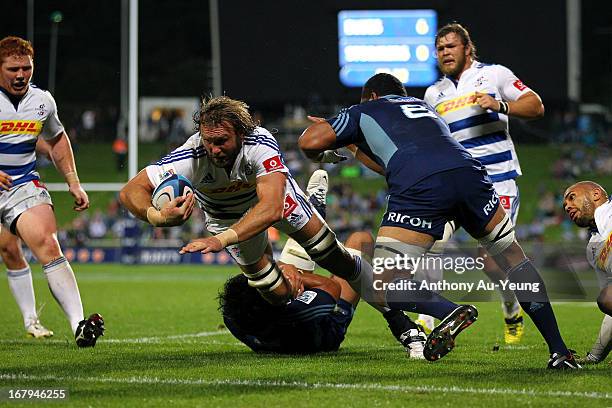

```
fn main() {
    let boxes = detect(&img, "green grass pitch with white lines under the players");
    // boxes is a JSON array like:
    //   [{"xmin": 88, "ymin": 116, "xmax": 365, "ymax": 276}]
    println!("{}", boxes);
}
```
[{"xmin": 0, "ymin": 264, "xmax": 612, "ymax": 407}]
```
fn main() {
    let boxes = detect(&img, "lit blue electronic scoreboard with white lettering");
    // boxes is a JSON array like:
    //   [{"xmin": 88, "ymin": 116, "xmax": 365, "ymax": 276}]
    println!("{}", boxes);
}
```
[{"xmin": 338, "ymin": 10, "xmax": 438, "ymax": 87}]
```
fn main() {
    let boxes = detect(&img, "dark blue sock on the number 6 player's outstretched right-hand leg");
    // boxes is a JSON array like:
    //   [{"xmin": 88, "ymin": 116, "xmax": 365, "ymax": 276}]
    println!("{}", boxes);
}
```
[{"xmin": 508, "ymin": 259, "xmax": 569, "ymax": 355}]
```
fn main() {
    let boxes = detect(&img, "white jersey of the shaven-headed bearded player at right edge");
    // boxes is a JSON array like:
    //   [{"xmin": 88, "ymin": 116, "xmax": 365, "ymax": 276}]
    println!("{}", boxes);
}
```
[{"xmin": 587, "ymin": 200, "xmax": 612, "ymax": 282}]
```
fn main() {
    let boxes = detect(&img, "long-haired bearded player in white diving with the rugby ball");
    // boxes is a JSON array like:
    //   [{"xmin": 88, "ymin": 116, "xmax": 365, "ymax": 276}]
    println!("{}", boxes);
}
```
[{"xmin": 120, "ymin": 97, "xmax": 426, "ymax": 356}]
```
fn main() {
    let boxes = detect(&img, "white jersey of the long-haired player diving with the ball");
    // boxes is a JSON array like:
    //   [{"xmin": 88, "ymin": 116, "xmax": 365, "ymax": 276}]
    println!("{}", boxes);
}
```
[{"xmin": 146, "ymin": 127, "xmax": 312, "ymax": 219}]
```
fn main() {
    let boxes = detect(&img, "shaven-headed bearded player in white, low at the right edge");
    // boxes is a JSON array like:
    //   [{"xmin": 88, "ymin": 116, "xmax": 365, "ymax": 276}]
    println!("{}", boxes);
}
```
[{"xmin": 563, "ymin": 181, "xmax": 612, "ymax": 364}]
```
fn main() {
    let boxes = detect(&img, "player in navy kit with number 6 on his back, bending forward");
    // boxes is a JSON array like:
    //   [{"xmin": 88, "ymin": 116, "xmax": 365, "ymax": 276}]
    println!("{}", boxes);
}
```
[{"xmin": 299, "ymin": 74, "xmax": 580, "ymax": 368}]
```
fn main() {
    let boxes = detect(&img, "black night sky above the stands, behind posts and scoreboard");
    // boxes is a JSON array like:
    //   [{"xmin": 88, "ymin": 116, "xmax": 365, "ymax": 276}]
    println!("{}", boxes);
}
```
[{"xmin": 0, "ymin": 0, "xmax": 612, "ymax": 109}]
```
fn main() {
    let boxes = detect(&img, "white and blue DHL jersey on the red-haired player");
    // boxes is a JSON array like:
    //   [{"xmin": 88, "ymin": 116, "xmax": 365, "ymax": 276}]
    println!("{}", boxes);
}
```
[{"xmin": 0, "ymin": 84, "xmax": 64, "ymax": 186}]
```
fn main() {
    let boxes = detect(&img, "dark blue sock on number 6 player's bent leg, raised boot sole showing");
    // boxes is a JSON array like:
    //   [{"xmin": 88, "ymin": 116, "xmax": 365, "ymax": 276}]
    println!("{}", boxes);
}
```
[{"xmin": 386, "ymin": 279, "xmax": 459, "ymax": 320}]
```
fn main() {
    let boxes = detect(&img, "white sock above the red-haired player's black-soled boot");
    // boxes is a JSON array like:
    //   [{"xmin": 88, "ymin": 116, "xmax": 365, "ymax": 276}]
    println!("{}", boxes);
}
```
[{"xmin": 43, "ymin": 256, "xmax": 83, "ymax": 333}]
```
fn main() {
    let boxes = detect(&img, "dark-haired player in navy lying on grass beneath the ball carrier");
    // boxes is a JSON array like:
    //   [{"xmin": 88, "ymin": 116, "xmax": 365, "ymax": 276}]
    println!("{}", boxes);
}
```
[{"xmin": 219, "ymin": 232, "xmax": 372, "ymax": 354}]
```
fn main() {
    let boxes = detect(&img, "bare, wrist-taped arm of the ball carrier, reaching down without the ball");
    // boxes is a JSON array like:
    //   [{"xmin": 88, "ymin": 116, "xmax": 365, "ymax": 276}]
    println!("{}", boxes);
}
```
[{"xmin": 179, "ymin": 172, "xmax": 287, "ymax": 254}]
